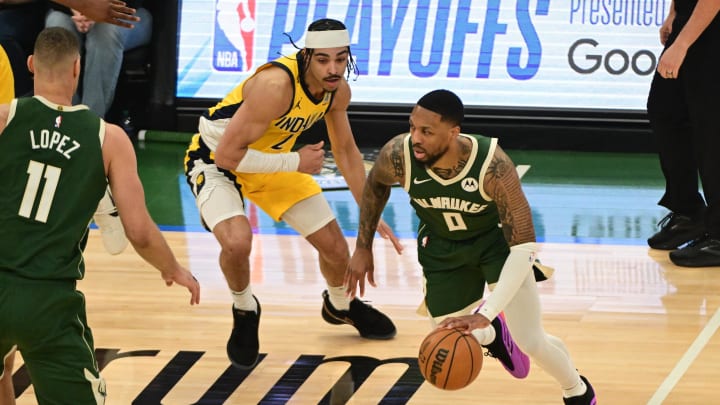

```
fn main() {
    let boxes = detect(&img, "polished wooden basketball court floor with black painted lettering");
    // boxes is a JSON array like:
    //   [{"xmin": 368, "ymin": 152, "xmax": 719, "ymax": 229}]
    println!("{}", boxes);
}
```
[{"xmin": 5, "ymin": 145, "xmax": 720, "ymax": 405}]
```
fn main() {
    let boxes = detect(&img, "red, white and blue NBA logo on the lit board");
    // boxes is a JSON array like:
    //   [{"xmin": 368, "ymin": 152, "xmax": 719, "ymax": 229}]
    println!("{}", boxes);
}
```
[{"xmin": 213, "ymin": 0, "xmax": 257, "ymax": 72}]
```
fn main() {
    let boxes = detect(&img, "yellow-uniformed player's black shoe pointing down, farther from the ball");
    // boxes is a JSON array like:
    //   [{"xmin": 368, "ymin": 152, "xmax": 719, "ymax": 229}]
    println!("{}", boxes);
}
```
[{"xmin": 227, "ymin": 295, "xmax": 260, "ymax": 370}]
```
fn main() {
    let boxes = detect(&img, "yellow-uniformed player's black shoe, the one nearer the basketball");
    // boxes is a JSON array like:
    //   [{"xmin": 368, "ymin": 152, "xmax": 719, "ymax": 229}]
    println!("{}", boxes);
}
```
[{"xmin": 322, "ymin": 290, "xmax": 397, "ymax": 340}]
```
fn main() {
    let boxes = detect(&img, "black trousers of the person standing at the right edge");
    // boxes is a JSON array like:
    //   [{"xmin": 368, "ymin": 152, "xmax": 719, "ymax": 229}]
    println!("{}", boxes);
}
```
[{"xmin": 647, "ymin": 15, "xmax": 720, "ymax": 238}]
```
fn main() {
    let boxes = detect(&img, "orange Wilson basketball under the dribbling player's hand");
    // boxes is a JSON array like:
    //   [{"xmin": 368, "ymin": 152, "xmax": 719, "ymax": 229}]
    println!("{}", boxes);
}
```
[{"xmin": 418, "ymin": 329, "xmax": 483, "ymax": 390}]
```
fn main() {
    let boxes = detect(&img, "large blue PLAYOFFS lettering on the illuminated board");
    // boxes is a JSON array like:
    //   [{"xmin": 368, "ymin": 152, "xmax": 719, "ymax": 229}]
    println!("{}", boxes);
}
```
[{"xmin": 267, "ymin": 0, "xmax": 550, "ymax": 80}]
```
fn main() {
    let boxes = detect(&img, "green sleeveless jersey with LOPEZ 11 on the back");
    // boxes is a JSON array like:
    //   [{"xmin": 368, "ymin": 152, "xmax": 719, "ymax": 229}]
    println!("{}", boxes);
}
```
[{"xmin": 0, "ymin": 96, "xmax": 107, "ymax": 279}]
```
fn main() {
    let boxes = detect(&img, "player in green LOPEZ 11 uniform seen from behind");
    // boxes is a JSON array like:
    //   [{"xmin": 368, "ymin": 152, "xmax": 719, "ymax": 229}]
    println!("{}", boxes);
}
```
[{"xmin": 0, "ymin": 27, "xmax": 200, "ymax": 404}]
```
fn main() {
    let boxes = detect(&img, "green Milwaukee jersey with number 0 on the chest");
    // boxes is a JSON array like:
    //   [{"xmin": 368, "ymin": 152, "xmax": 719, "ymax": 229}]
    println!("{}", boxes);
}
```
[{"xmin": 403, "ymin": 134, "xmax": 500, "ymax": 240}]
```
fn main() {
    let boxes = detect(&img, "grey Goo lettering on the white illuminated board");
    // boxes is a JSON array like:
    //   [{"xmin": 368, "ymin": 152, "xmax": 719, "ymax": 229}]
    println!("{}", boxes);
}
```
[{"xmin": 568, "ymin": 38, "xmax": 657, "ymax": 76}]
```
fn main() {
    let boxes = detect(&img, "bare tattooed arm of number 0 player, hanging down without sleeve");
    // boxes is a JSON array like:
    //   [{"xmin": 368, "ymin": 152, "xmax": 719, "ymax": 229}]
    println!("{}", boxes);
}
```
[{"xmin": 345, "ymin": 134, "xmax": 405, "ymax": 297}]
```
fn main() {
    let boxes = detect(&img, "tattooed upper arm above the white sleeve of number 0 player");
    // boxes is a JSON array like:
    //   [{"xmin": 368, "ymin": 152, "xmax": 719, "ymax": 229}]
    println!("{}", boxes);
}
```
[{"xmin": 483, "ymin": 145, "xmax": 535, "ymax": 246}]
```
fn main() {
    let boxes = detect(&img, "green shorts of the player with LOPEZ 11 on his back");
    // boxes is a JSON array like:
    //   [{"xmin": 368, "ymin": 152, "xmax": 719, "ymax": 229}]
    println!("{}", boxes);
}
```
[{"xmin": 0, "ymin": 270, "xmax": 105, "ymax": 404}]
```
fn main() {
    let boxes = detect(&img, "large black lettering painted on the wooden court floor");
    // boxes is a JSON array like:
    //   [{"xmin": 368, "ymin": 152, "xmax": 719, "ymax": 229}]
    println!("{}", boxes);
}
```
[{"xmin": 8, "ymin": 348, "xmax": 425, "ymax": 404}]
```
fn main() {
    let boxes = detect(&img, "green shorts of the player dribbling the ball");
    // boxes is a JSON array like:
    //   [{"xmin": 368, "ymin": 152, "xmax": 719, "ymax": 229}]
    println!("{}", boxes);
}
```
[{"xmin": 417, "ymin": 226, "xmax": 510, "ymax": 317}]
